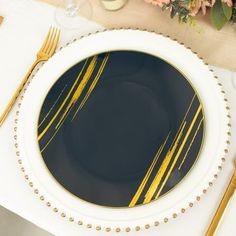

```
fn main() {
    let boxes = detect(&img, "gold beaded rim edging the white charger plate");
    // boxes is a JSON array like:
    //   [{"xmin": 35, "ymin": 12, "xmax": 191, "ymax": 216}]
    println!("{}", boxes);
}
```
[{"xmin": 13, "ymin": 27, "xmax": 232, "ymax": 233}]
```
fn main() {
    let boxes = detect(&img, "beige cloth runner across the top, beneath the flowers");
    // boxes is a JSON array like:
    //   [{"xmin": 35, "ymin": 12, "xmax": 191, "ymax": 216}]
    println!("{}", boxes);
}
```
[{"xmin": 40, "ymin": 0, "xmax": 236, "ymax": 71}]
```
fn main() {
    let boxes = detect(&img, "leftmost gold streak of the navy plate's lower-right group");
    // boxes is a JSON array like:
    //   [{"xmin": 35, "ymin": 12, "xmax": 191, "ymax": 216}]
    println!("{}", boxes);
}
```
[{"xmin": 129, "ymin": 132, "xmax": 170, "ymax": 207}]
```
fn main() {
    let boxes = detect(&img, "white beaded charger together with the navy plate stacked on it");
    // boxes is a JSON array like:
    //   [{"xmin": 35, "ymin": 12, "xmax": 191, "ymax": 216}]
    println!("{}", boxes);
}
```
[{"xmin": 15, "ymin": 30, "xmax": 230, "ymax": 231}]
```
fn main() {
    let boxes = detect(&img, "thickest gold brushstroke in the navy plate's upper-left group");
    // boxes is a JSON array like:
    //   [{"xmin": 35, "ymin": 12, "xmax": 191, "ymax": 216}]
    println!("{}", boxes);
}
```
[{"xmin": 56, "ymin": 56, "xmax": 98, "ymax": 129}]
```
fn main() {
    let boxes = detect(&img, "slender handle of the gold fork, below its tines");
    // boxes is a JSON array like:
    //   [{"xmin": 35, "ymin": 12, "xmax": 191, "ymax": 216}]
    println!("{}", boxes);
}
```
[{"xmin": 0, "ymin": 59, "xmax": 40, "ymax": 126}]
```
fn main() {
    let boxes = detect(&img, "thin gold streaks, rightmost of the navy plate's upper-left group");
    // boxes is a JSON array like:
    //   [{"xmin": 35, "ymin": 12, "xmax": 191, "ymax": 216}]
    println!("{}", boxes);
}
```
[{"xmin": 71, "ymin": 53, "xmax": 109, "ymax": 121}]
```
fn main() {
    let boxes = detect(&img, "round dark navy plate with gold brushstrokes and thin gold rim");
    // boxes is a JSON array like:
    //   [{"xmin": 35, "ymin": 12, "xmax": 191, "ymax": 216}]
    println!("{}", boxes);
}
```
[{"xmin": 38, "ymin": 51, "xmax": 204, "ymax": 207}]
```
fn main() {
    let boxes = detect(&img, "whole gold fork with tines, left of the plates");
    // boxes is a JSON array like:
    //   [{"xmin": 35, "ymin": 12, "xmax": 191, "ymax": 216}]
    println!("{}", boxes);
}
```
[{"xmin": 0, "ymin": 27, "xmax": 60, "ymax": 126}]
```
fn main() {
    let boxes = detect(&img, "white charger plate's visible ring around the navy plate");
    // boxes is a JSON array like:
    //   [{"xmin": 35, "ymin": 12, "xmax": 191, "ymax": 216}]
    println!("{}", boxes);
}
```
[{"xmin": 14, "ymin": 30, "xmax": 230, "ymax": 232}]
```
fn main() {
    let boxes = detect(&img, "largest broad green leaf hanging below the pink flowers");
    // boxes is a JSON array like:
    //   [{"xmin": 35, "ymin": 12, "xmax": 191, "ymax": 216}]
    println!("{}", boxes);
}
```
[{"xmin": 211, "ymin": 0, "xmax": 228, "ymax": 30}]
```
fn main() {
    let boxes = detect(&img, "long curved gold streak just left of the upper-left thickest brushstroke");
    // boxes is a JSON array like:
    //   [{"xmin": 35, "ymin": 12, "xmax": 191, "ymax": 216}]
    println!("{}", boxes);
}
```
[{"xmin": 38, "ymin": 59, "xmax": 88, "ymax": 141}]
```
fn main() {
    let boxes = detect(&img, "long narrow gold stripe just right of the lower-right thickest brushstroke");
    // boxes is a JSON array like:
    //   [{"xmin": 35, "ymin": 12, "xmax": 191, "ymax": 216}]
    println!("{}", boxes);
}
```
[{"xmin": 155, "ymin": 105, "xmax": 202, "ymax": 199}]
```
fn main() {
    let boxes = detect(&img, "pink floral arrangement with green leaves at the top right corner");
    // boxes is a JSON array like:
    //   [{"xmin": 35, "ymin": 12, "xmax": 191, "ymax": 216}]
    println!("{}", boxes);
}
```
[{"xmin": 145, "ymin": 0, "xmax": 236, "ymax": 30}]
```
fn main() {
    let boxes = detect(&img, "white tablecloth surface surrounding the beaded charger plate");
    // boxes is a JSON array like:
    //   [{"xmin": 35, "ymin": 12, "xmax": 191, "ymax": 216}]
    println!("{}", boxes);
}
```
[{"xmin": 0, "ymin": 0, "xmax": 236, "ymax": 236}]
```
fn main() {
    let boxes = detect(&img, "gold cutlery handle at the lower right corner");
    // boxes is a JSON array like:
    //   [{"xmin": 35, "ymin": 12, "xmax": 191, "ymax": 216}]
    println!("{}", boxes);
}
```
[{"xmin": 205, "ymin": 170, "xmax": 236, "ymax": 236}]
